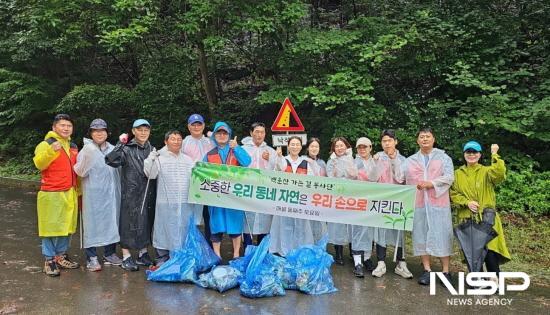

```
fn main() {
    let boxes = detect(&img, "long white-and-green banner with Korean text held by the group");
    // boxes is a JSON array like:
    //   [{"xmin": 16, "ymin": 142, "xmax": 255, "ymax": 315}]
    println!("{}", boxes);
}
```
[{"xmin": 189, "ymin": 162, "xmax": 416, "ymax": 231}]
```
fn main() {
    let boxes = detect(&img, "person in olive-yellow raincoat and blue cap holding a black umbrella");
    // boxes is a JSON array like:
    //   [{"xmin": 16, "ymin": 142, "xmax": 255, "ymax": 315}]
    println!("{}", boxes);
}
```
[{"xmin": 451, "ymin": 141, "xmax": 510, "ymax": 276}]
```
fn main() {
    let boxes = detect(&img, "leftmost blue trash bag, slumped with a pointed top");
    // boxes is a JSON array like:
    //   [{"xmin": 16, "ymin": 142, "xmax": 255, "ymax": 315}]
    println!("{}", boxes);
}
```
[{"xmin": 146, "ymin": 216, "xmax": 221, "ymax": 282}]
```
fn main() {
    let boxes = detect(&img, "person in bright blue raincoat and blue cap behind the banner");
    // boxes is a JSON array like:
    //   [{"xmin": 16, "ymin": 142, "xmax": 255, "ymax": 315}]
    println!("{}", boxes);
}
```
[{"xmin": 203, "ymin": 121, "xmax": 251, "ymax": 258}]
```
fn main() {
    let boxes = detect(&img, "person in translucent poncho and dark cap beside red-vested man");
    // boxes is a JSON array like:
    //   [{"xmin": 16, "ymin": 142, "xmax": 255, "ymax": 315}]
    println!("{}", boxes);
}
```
[{"xmin": 73, "ymin": 118, "xmax": 122, "ymax": 271}]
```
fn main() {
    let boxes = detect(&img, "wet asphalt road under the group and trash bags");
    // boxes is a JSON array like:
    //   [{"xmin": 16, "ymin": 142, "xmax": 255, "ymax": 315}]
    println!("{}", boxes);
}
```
[{"xmin": 0, "ymin": 185, "xmax": 550, "ymax": 314}]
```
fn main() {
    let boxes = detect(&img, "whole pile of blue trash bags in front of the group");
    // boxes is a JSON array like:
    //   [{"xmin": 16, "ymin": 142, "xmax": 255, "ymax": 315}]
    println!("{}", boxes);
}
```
[{"xmin": 147, "ymin": 218, "xmax": 338, "ymax": 298}]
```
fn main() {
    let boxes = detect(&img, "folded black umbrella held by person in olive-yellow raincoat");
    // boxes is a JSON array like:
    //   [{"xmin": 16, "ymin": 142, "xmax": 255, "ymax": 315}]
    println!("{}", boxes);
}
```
[{"xmin": 454, "ymin": 208, "xmax": 498, "ymax": 272}]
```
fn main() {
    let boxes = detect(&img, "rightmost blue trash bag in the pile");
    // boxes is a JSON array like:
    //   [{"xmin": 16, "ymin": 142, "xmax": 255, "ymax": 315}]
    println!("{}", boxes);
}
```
[{"xmin": 283, "ymin": 235, "xmax": 338, "ymax": 295}]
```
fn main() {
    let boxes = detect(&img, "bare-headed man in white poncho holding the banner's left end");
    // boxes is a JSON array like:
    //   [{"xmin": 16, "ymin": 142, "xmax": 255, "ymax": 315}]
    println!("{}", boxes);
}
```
[{"xmin": 143, "ymin": 130, "xmax": 193, "ymax": 266}]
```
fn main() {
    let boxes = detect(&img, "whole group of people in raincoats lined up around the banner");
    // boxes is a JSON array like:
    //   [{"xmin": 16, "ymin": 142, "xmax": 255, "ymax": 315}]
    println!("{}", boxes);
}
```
[{"xmin": 34, "ymin": 114, "xmax": 510, "ymax": 285}]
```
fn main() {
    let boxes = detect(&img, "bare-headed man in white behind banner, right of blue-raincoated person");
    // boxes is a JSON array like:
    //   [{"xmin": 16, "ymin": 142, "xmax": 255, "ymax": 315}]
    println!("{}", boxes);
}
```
[{"xmin": 241, "ymin": 122, "xmax": 277, "ymax": 252}]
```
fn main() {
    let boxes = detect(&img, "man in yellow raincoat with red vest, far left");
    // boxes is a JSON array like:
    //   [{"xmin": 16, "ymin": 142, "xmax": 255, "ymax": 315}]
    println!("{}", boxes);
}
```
[{"xmin": 33, "ymin": 114, "xmax": 79, "ymax": 277}]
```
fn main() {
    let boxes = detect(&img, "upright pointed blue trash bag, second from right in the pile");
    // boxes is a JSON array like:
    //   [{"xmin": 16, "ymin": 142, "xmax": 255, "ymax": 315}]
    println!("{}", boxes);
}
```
[{"xmin": 240, "ymin": 235, "xmax": 285, "ymax": 298}]
